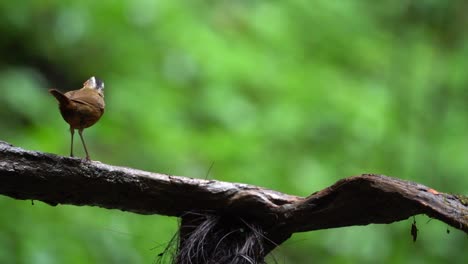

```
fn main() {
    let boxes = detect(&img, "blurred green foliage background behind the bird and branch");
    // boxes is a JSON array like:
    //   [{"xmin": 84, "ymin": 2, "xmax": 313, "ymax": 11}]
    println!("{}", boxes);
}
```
[{"xmin": 0, "ymin": 0, "xmax": 468, "ymax": 263}]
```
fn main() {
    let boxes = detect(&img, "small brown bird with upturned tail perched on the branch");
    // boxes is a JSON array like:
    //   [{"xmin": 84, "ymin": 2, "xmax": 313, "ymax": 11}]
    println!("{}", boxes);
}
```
[{"xmin": 49, "ymin": 76, "xmax": 105, "ymax": 160}]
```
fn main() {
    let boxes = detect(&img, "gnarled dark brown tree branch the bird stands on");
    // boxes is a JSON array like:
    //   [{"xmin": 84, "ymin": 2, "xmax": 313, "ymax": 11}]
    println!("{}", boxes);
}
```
[{"xmin": 0, "ymin": 141, "xmax": 468, "ymax": 237}]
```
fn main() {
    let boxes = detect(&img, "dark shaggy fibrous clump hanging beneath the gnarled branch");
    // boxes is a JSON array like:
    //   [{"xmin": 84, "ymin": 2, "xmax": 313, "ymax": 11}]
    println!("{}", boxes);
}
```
[{"xmin": 157, "ymin": 213, "xmax": 274, "ymax": 264}]
